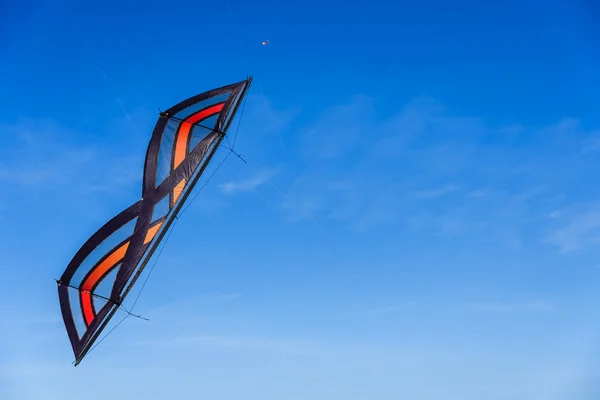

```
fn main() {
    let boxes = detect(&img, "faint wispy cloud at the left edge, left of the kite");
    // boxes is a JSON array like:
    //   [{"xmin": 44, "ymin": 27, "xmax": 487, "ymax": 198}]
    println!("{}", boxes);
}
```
[{"xmin": 0, "ymin": 118, "xmax": 143, "ymax": 192}]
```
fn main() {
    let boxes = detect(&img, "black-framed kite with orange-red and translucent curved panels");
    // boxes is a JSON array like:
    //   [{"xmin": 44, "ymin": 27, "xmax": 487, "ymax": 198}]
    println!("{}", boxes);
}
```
[{"xmin": 57, "ymin": 77, "xmax": 252, "ymax": 365}]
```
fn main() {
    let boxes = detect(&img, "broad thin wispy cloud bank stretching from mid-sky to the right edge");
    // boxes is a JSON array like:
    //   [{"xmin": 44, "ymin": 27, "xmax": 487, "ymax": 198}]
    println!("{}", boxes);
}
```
[{"xmin": 276, "ymin": 96, "xmax": 597, "ymax": 248}]
